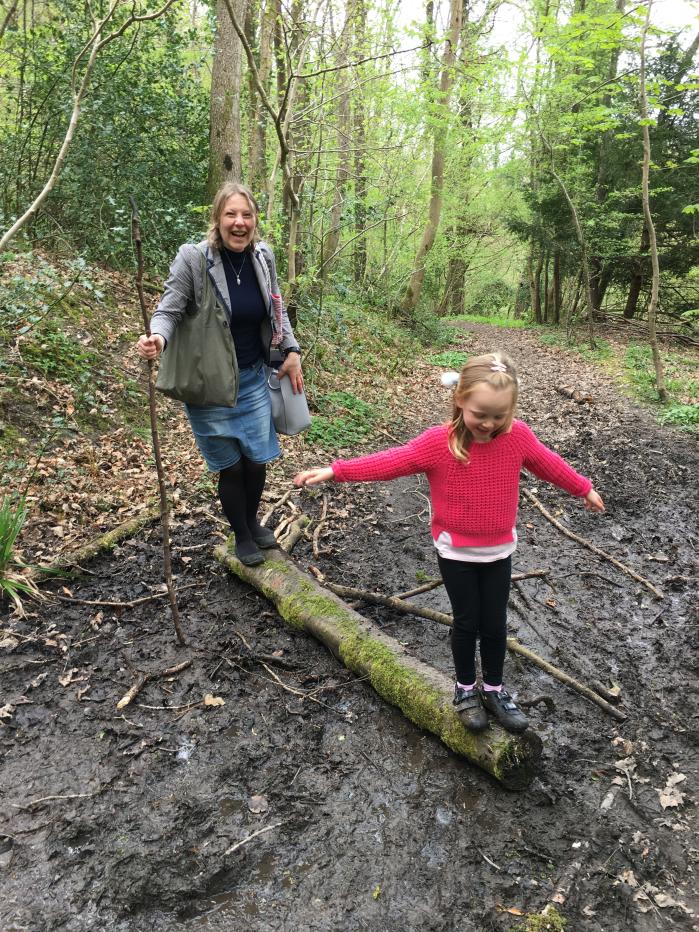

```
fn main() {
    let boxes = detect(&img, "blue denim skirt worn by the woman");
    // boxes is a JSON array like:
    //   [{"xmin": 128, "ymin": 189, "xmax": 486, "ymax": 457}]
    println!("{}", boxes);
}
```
[{"xmin": 185, "ymin": 360, "xmax": 281, "ymax": 472}]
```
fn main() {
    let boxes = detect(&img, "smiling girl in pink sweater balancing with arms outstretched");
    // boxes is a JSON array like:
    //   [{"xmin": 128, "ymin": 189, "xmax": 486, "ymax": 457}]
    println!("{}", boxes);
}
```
[{"xmin": 294, "ymin": 352, "xmax": 604, "ymax": 732}]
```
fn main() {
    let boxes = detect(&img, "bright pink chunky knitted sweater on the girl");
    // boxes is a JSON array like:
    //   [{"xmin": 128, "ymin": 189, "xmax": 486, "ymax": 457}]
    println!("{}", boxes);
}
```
[{"xmin": 332, "ymin": 421, "xmax": 592, "ymax": 547}]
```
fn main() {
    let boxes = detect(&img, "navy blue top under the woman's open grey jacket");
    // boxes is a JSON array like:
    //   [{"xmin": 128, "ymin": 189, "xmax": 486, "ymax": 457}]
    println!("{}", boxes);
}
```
[{"xmin": 221, "ymin": 247, "xmax": 267, "ymax": 369}]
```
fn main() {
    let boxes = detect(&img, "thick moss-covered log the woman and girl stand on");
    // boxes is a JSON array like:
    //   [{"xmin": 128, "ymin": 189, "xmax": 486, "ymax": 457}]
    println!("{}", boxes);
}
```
[{"xmin": 215, "ymin": 545, "xmax": 542, "ymax": 790}]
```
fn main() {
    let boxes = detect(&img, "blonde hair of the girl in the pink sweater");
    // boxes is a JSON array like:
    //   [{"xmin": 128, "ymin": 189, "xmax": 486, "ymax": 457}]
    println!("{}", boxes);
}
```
[{"xmin": 449, "ymin": 352, "xmax": 519, "ymax": 463}]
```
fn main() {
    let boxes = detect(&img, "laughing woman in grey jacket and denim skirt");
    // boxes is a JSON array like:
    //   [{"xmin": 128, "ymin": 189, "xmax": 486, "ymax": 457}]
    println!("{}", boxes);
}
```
[{"xmin": 136, "ymin": 183, "xmax": 303, "ymax": 566}]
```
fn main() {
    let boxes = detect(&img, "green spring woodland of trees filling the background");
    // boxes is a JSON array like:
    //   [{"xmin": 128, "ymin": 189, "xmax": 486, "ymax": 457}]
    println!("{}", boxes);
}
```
[{"xmin": 0, "ymin": 0, "xmax": 699, "ymax": 329}]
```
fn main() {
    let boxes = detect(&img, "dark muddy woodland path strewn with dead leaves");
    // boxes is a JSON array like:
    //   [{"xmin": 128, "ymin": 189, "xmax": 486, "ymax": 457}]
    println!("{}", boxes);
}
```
[{"xmin": 0, "ymin": 328, "xmax": 699, "ymax": 932}]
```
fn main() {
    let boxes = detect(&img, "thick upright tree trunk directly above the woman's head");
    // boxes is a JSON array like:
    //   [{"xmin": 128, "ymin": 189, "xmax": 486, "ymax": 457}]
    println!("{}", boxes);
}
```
[{"xmin": 208, "ymin": 0, "xmax": 247, "ymax": 197}]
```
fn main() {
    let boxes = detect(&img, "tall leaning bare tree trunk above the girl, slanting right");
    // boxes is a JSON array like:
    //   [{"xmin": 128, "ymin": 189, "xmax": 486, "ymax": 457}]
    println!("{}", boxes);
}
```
[{"xmin": 401, "ymin": 0, "xmax": 463, "ymax": 317}]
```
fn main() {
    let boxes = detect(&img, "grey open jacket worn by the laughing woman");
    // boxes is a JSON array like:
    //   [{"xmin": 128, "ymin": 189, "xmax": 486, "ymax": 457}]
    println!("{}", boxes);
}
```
[{"xmin": 150, "ymin": 240, "xmax": 297, "ymax": 362}]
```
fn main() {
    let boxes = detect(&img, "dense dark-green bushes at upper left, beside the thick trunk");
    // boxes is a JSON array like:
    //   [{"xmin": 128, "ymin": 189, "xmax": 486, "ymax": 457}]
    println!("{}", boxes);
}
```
[{"xmin": 0, "ymin": 7, "xmax": 209, "ymax": 270}]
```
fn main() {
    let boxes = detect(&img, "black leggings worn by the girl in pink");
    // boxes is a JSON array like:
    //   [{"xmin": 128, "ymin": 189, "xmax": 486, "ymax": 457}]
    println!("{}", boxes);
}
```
[{"xmin": 437, "ymin": 556, "xmax": 512, "ymax": 686}]
